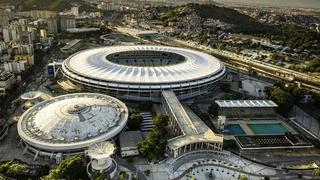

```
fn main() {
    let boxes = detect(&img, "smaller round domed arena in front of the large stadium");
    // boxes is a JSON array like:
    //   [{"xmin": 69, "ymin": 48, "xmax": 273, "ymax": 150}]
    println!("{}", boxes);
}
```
[{"xmin": 18, "ymin": 93, "xmax": 128, "ymax": 160}]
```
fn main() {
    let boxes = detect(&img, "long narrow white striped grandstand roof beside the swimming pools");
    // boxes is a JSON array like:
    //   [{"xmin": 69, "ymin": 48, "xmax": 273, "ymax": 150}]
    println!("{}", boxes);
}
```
[{"xmin": 215, "ymin": 100, "xmax": 278, "ymax": 108}]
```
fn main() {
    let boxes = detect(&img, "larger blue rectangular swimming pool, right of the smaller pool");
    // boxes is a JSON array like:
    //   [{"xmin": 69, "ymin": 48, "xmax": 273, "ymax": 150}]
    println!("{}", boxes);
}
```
[{"xmin": 248, "ymin": 123, "xmax": 288, "ymax": 135}]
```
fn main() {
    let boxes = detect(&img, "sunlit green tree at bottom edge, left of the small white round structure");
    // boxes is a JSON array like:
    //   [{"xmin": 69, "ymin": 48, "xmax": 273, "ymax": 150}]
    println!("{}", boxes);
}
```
[{"xmin": 44, "ymin": 155, "xmax": 87, "ymax": 180}]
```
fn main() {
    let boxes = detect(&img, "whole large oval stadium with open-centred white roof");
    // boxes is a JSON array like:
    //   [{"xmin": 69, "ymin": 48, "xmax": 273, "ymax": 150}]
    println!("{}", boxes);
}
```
[{"xmin": 62, "ymin": 45, "xmax": 226, "ymax": 101}]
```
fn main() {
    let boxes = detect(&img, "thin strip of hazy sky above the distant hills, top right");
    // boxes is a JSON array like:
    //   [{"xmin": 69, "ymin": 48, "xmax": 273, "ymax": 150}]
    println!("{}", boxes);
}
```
[{"xmin": 215, "ymin": 0, "xmax": 320, "ymax": 9}]
